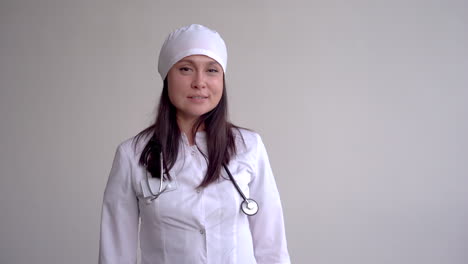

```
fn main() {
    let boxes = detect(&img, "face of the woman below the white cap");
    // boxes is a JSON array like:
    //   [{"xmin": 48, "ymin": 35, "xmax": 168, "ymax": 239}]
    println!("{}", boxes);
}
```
[{"xmin": 167, "ymin": 55, "xmax": 224, "ymax": 121}]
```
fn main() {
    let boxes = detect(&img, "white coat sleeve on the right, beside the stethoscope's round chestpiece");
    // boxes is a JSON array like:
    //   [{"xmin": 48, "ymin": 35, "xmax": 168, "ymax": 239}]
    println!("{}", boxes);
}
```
[{"xmin": 249, "ymin": 135, "xmax": 290, "ymax": 264}]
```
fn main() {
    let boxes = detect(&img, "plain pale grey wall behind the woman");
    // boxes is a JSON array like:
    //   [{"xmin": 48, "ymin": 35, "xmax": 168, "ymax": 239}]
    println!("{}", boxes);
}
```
[{"xmin": 0, "ymin": 0, "xmax": 468, "ymax": 264}]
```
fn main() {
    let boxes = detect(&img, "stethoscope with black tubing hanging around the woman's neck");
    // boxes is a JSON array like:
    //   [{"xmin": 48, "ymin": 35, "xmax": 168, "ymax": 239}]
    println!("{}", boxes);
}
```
[{"xmin": 145, "ymin": 156, "xmax": 258, "ymax": 216}]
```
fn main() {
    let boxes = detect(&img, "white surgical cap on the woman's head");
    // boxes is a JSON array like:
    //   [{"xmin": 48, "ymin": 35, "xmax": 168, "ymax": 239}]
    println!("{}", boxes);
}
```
[{"xmin": 158, "ymin": 24, "xmax": 227, "ymax": 80}]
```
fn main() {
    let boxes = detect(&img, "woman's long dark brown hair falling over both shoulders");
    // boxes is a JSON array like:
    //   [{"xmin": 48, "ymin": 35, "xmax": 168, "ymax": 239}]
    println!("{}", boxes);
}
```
[{"xmin": 133, "ymin": 77, "xmax": 240, "ymax": 187}]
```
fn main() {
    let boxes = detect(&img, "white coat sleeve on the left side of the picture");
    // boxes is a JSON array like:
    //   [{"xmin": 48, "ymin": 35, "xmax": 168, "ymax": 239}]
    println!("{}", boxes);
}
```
[{"xmin": 99, "ymin": 145, "xmax": 139, "ymax": 264}]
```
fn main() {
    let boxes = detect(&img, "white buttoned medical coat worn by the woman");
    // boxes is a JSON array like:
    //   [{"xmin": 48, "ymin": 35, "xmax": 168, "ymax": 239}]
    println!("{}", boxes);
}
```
[{"xmin": 99, "ymin": 130, "xmax": 290, "ymax": 264}]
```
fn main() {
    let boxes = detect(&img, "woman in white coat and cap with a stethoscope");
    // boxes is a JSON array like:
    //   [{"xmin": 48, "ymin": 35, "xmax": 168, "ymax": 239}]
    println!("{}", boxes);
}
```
[{"xmin": 99, "ymin": 25, "xmax": 290, "ymax": 264}]
